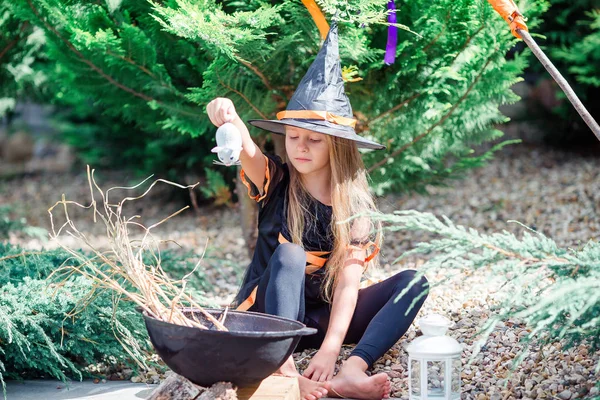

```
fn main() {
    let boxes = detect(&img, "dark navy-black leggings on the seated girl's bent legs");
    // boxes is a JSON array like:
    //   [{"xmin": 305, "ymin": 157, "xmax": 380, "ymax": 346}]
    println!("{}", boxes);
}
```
[{"xmin": 251, "ymin": 243, "xmax": 429, "ymax": 367}]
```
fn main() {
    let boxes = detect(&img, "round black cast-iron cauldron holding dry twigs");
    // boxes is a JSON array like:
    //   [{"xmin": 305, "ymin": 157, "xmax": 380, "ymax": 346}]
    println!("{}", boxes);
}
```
[{"xmin": 144, "ymin": 309, "xmax": 317, "ymax": 387}]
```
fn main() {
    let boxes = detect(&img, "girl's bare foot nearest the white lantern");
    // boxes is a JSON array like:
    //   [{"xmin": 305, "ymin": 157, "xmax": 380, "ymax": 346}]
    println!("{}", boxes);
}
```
[{"xmin": 329, "ymin": 368, "xmax": 391, "ymax": 400}]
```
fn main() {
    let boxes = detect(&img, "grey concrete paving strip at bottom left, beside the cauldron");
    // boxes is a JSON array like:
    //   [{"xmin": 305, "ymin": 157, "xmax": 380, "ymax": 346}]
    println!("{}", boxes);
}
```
[{"xmin": 0, "ymin": 380, "xmax": 158, "ymax": 400}]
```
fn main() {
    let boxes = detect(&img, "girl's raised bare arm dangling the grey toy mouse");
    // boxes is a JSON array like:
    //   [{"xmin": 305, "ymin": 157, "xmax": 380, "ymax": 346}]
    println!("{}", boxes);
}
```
[{"xmin": 206, "ymin": 97, "xmax": 266, "ymax": 194}]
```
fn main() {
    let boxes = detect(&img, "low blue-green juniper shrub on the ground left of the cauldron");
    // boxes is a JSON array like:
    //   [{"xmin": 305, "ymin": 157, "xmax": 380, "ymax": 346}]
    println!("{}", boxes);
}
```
[{"xmin": 0, "ymin": 277, "xmax": 149, "ymax": 388}]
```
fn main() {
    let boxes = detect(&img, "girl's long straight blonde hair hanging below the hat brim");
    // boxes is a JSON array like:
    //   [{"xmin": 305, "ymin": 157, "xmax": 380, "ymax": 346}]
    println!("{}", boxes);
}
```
[{"xmin": 287, "ymin": 135, "xmax": 383, "ymax": 302}]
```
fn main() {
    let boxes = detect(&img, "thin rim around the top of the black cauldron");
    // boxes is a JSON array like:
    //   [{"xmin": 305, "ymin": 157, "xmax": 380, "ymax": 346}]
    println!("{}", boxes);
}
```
[{"xmin": 138, "ymin": 307, "xmax": 317, "ymax": 338}]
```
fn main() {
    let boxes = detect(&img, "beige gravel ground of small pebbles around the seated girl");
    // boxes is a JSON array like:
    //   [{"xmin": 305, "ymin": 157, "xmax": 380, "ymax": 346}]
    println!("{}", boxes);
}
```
[{"xmin": 0, "ymin": 145, "xmax": 600, "ymax": 400}]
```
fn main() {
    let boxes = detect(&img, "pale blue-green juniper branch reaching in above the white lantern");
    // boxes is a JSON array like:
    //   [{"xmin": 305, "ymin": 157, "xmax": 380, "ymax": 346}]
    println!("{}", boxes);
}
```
[{"xmin": 374, "ymin": 211, "xmax": 600, "ymax": 371}]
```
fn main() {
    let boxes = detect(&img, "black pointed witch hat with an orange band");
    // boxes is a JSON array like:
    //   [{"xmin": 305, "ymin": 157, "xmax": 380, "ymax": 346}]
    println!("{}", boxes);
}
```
[{"xmin": 248, "ymin": 21, "xmax": 385, "ymax": 150}]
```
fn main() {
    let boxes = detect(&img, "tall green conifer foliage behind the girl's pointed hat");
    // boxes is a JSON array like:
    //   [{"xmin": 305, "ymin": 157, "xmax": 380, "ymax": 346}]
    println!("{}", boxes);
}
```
[{"xmin": 6, "ymin": 0, "xmax": 545, "ymax": 194}]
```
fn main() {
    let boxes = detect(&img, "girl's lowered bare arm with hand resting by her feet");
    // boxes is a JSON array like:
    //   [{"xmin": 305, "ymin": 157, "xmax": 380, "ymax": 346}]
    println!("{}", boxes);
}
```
[{"xmin": 304, "ymin": 249, "xmax": 366, "ymax": 382}]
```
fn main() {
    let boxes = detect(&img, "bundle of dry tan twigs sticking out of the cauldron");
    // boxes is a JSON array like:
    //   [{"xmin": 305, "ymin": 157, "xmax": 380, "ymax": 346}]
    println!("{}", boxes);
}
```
[{"xmin": 48, "ymin": 166, "xmax": 227, "ymax": 330}]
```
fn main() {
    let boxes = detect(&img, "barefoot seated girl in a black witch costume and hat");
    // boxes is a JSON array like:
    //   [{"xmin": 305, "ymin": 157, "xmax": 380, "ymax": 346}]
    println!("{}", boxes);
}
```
[{"xmin": 207, "ymin": 24, "xmax": 427, "ymax": 400}]
